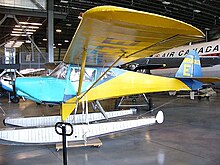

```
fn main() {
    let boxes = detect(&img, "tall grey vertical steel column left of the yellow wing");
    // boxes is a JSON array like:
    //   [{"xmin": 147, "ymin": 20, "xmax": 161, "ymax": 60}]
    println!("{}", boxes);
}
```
[{"xmin": 47, "ymin": 0, "xmax": 54, "ymax": 62}]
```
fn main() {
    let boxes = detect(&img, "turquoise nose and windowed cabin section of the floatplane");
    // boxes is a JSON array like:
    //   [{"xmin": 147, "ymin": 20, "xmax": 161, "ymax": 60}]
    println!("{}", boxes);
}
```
[{"xmin": 15, "ymin": 63, "xmax": 125, "ymax": 104}]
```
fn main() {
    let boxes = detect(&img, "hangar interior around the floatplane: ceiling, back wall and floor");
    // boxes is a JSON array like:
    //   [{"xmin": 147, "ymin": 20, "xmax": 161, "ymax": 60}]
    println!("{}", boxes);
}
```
[{"xmin": 0, "ymin": 0, "xmax": 220, "ymax": 165}]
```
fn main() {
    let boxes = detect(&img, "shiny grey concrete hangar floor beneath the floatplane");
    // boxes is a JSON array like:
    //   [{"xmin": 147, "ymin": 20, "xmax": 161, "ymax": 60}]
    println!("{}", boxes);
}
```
[{"xmin": 0, "ymin": 94, "xmax": 220, "ymax": 165}]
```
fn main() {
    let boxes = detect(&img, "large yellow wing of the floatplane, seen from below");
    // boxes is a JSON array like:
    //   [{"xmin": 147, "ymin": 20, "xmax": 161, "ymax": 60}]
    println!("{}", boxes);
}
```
[{"xmin": 64, "ymin": 6, "xmax": 204, "ymax": 66}]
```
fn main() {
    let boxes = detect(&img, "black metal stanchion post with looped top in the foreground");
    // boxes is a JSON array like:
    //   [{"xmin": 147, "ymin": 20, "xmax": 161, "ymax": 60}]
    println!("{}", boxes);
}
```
[{"xmin": 55, "ymin": 122, "xmax": 73, "ymax": 165}]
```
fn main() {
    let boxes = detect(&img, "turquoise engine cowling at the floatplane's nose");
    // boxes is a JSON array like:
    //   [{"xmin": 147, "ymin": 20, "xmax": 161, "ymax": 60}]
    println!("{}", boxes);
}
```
[{"xmin": 15, "ymin": 77, "xmax": 66, "ymax": 103}]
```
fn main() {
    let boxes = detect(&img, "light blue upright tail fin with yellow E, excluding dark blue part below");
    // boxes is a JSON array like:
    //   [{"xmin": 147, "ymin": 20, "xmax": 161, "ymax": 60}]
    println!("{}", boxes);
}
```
[{"xmin": 175, "ymin": 50, "xmax": 202, "ymax": 78}]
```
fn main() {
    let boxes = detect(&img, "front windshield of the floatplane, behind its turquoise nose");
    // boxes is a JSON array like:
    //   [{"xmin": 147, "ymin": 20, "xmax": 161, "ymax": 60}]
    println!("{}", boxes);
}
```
[{"xmin": 50, "ymin": 63, "xmax": 68, "ymax": 79}]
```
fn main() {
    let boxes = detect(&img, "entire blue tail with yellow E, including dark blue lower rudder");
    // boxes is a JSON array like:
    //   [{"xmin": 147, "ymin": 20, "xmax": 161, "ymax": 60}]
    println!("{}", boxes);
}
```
[{"xmin": 175, "ymin": 50, "xmax": 203, "ymax": 90}]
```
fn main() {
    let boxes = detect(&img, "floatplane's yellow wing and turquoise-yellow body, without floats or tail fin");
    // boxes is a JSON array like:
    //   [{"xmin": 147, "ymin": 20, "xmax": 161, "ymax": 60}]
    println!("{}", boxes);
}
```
[{"xmin": 15, "ymin": 6, "xmax": 208, "ymax": 120}]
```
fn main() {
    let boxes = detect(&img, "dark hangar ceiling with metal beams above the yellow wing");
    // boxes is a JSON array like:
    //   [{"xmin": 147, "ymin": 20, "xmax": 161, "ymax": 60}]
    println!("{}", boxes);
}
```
[{"xmin": 0, "ymin": 0, "xmax": 220, "ymax": 49}]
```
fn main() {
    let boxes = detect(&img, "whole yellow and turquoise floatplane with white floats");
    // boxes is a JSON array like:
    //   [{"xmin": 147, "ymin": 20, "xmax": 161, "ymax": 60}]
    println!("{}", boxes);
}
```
[{"xmin": 0, "ymin": 6, "xmax": 219, "ymax": 143}]
